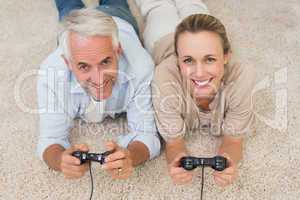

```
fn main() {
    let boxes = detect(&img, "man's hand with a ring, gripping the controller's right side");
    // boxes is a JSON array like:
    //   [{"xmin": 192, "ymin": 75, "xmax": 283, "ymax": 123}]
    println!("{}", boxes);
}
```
[{"xmin": 102, "ymin": 142, "xmax": 134, "ymax": 179}]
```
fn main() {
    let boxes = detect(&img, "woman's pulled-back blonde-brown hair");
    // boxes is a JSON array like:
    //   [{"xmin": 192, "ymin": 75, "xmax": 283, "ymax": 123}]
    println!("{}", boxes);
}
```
[{"xmin": 175, "ymin": 14, "xmax": 231, "ymax": 55}]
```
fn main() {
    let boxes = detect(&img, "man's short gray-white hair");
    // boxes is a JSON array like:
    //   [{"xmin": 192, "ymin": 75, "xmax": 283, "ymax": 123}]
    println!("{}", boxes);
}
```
[{"xmin": 59, "ymin": 8, "xmax": 119, "ymax": 59}]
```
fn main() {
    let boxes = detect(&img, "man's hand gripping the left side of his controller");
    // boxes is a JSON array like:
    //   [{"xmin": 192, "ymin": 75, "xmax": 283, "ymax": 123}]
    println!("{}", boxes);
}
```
[{"xmin": 60, "ymin": 144, "xmax": 89, "ymax": 179}]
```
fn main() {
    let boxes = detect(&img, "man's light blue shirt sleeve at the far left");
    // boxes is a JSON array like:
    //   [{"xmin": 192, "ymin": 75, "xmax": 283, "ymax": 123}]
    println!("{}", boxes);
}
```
[{"xmin": 37, "ymin": 67, "xmax": 74, "ymax": 160}]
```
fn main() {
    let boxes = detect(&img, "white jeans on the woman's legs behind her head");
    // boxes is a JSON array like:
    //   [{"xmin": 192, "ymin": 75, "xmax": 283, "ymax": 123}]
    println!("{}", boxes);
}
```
[{"xmin": 135, "ymin": 0, "xmax": 209, "ymax": 53}]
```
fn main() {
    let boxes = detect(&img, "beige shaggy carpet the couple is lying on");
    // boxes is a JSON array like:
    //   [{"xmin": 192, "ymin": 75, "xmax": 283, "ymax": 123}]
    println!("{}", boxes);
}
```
[{"xmin": 0, "ymin": 0, "xmax": 300, "ymax": 200}]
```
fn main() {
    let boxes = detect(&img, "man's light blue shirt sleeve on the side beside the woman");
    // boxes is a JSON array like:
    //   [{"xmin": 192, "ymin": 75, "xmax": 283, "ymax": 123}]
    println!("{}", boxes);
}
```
[{"xmin": 116, "ymin": 20, "xmax": 161, "ymax": 159}]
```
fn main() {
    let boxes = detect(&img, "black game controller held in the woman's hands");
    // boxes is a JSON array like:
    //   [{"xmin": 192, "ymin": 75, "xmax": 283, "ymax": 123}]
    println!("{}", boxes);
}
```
[{"xmin": 180, "ymin": 156, "xmax": 227, "ymax": 171}]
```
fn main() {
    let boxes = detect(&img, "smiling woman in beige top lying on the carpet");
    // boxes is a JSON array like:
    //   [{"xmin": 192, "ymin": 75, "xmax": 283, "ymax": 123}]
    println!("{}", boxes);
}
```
[{"xmin": 153, "ymin": 14, "xmax": 255, "ymax": 186}]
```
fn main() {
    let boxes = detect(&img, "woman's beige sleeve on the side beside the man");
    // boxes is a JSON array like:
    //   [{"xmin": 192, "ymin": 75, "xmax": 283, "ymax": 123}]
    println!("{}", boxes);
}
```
[{"xmin": 152, "ymin": 58, "xmax": 187, "ymax": 141}]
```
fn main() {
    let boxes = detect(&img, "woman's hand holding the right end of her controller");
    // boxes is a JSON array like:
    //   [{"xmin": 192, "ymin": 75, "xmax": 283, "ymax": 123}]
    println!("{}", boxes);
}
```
[{"xmin": 213, "ymin": 153, "xmax": 238, "ymax": 187}]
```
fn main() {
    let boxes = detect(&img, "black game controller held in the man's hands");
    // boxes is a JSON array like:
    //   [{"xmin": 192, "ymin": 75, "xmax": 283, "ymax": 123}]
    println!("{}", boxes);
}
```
[{"xmin": 72, "ymin": 151, "xmax": 113, "ymax": 165}]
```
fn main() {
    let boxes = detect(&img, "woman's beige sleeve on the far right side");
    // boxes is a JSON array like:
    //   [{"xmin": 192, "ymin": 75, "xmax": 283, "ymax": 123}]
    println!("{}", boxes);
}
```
[{"xmin": 222, "ymin": 66, "xmax": 256, "ymax": 136}]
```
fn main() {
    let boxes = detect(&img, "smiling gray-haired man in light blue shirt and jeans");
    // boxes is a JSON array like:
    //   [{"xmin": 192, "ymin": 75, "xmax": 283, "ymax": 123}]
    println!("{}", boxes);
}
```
[{"xmin": 37, "ymin": 0, "xmax": 160, "ymax": 179}]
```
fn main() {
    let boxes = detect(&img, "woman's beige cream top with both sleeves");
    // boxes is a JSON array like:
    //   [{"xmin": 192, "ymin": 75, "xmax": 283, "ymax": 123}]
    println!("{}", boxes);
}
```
[{"xmin": 152, "ymin": 35, "xmax": 255, "ymax": 140}]
